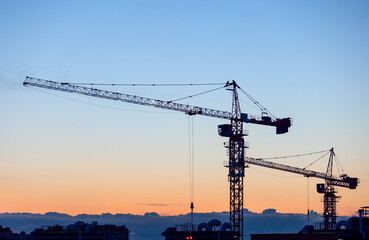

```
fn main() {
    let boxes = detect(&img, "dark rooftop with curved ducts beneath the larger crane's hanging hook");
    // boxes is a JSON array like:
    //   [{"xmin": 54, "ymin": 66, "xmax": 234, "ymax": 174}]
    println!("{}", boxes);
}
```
[{"xmin": 161, "ymin": 219, "xmax": 239, "ymax": 240}]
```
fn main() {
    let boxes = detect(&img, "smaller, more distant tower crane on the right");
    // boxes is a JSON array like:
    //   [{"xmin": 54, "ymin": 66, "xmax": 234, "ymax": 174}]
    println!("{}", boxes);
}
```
[{"xmin": 245, "ymin": 148, "xmax": 359, "ymax": 230}]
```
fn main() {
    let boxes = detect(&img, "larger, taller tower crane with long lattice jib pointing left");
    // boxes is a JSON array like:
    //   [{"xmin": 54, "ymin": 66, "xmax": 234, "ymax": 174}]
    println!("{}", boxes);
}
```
[{"xmin": 23, "ymin": 76, "xmax": 291, "ymax": 240}]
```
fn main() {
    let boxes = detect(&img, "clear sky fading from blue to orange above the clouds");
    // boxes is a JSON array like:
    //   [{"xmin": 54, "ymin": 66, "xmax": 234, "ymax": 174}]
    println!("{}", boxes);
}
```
[{"xmin": 0, "ymin": 0, "xmax": 369, "ymax": 216}]
